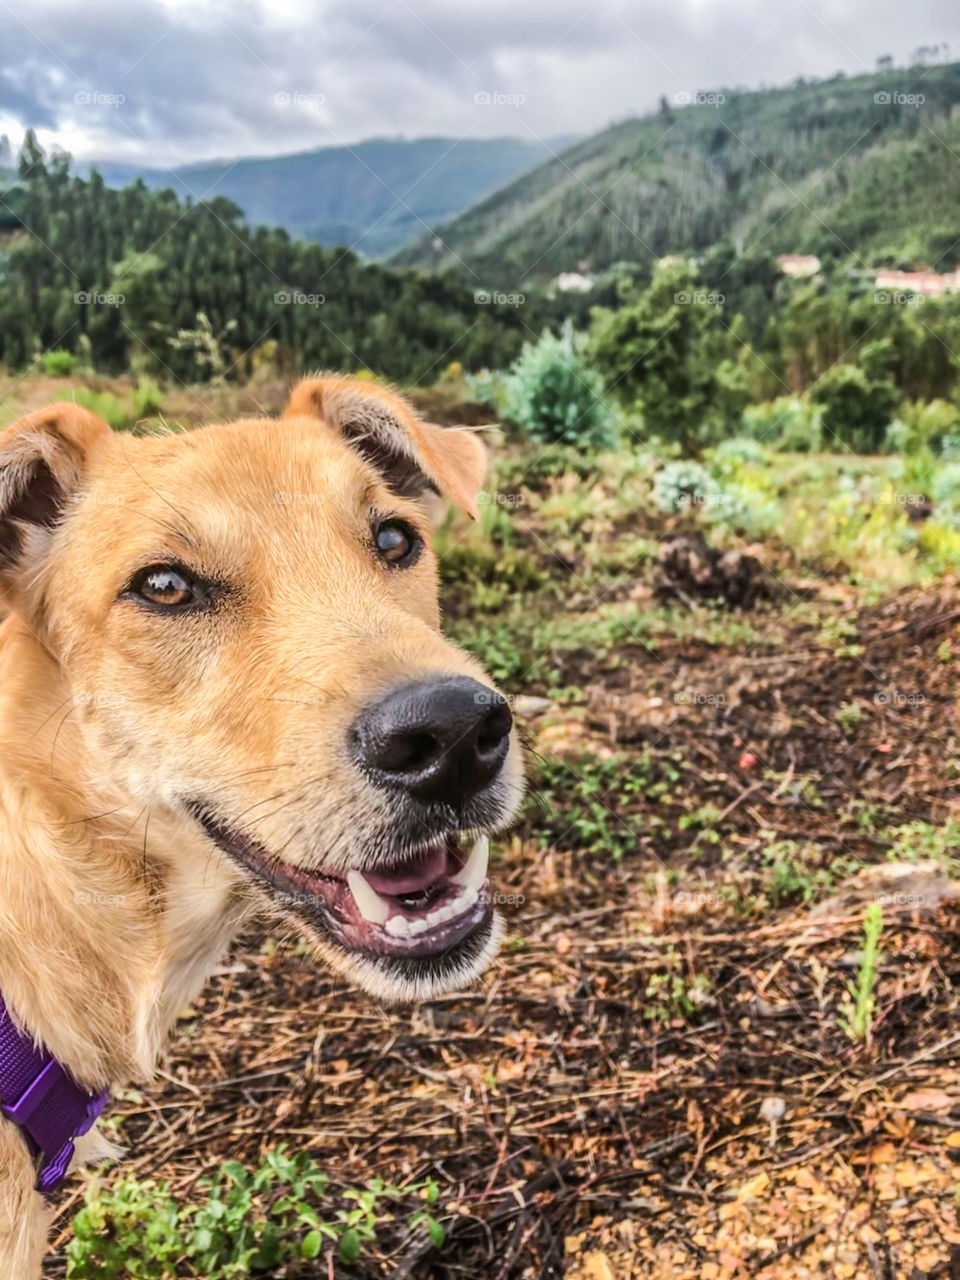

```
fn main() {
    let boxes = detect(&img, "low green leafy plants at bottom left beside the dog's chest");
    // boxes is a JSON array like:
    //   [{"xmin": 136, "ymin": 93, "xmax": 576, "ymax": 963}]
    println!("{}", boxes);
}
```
[{"xmin": 67, "ymin": 1146, "xmax": 443, "ymax": 1280}]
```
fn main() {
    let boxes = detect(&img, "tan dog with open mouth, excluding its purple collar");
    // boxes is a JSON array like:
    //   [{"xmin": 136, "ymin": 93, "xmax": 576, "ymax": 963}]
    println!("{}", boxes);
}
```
[{"xmin": 0, "ymin": 378, "xmax": 522, "ymax": 1280}]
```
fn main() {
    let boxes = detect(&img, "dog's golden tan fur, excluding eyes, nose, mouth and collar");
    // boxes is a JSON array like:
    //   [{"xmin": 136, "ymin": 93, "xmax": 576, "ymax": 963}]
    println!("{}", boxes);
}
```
[{"xmin": 0, "ymin": 378, "xmax": 521, "ymax": 1280}]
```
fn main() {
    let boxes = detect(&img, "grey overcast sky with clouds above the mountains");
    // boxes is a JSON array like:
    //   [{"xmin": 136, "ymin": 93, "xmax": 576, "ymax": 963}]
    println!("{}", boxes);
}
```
[{"xmin": 0, "ymin": 0, "xmax": 960, "ymax": 165}]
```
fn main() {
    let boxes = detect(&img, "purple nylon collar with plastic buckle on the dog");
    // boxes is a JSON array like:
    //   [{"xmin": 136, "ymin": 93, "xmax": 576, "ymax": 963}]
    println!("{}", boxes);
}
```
[{"xmin": 0, "ymin": 996, "xmax": 110, "ymax": 1193}]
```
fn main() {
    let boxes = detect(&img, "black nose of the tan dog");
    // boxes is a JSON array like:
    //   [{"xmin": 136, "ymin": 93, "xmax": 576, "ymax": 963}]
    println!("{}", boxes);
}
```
[{"xmin": 351, "ymin": 676, "xmax": 513, "ymax": 805}]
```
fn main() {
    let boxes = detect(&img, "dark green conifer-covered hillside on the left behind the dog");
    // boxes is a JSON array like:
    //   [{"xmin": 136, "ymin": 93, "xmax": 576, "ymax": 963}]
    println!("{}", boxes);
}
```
[{"xmin": 0, "ymin": 136, "xmax": 535, "ymax": 383}]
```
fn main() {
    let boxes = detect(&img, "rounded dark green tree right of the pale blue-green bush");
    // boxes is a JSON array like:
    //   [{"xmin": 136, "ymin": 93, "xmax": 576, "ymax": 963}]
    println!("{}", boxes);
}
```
[{"xmin": 590, "ymin": 259, "xmax": 749, "ymax": 452}]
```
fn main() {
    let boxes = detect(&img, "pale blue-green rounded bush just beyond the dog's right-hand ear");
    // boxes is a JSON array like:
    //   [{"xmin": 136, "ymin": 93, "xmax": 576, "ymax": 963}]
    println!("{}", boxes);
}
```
[{"xmin": 500, "ymin": 323, "xmax": 616, "ymax": 449}]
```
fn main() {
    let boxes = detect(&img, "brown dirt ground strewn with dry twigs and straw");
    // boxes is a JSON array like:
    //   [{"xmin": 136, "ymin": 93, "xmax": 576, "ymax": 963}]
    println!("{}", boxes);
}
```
[{"xmin": 16, "ymin": 373, "xmax": 960, "ymax": 1280}]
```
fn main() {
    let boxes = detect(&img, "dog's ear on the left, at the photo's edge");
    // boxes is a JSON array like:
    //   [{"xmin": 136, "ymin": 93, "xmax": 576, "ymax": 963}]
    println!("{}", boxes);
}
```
[{"xmin": 0, "ymin": 403, "xmax": 110, "ymax": 612}]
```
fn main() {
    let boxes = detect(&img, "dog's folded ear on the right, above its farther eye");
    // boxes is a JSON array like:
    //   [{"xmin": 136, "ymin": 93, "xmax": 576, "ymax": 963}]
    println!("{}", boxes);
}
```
[{"xmin": 283, "ymin": 378, "xmax": 486, "ymax": 520}]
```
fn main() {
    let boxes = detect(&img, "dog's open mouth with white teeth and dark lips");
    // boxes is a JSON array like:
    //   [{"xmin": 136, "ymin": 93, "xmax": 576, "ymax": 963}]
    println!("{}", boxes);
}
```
[{"xmin": 191, "ymin": 805, "xmax": 493, "ymax": 961}]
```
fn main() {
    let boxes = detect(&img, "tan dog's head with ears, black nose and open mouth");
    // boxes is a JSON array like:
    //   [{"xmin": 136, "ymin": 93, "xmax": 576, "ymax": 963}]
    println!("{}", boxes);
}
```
[{"xmin": 0, "ymin": 378, "xmax": 522, "ymax": 998}]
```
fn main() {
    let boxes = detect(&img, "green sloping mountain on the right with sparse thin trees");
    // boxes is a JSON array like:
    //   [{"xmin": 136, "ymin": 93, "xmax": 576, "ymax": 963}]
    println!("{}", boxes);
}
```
[{"xmin": 397, "ymin": 63, "xmax": 960, "ymax": 280}]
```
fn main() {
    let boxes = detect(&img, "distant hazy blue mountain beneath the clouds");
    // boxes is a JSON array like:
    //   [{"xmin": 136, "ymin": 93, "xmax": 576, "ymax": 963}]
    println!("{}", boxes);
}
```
[{"xmin": 82, "ymin": 138, "xmax": 570, "ymax": 257}]
